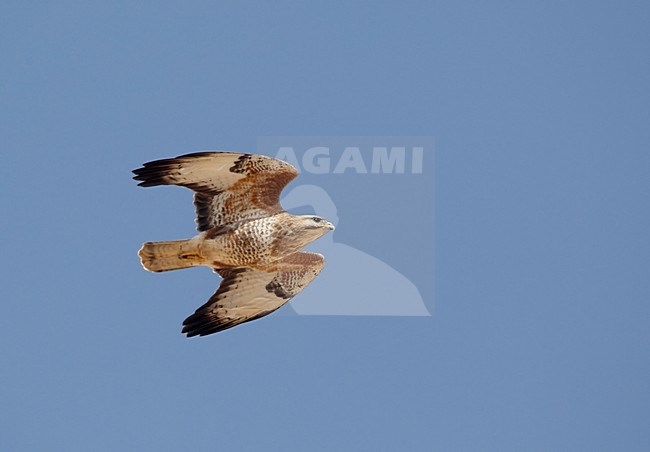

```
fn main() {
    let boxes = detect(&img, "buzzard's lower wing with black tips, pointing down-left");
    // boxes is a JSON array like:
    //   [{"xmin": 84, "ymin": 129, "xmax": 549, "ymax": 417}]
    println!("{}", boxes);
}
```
[{"xmin": 182, "ymin": 252, "xmax": 325, "ymax": 337}]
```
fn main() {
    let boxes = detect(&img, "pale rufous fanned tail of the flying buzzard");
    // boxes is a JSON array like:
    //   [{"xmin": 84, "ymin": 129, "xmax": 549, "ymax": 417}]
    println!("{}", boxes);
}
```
[{"xmin": 138, "ymin": 240, "xmax": 204, "ymax": 272}]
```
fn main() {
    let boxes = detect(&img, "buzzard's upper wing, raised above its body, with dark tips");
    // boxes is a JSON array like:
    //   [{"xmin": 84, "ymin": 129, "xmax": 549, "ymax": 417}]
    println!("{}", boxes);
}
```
[{"xmin": 133, "ymin": 152, "xmax": 298, "ymax": 231}]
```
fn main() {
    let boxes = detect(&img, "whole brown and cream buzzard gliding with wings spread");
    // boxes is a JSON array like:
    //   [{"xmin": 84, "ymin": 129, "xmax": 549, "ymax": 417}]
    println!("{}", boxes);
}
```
[{"xmin": 133, "ymin": 152, "xmax": 334, "ymax": 337}]
